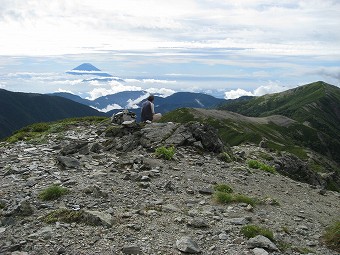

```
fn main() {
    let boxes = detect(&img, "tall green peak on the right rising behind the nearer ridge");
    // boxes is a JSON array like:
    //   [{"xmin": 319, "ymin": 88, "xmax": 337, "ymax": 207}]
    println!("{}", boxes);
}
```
[{"xmin": 220, "ymin": 81, "xmax": 340, "ymax": 162}]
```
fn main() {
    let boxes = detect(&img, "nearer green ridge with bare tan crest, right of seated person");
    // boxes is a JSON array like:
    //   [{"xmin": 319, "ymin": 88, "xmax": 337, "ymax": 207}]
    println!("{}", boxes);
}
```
[{"xmin": 161, "ymin": 108, "xmax": 340, "ymax": 190}]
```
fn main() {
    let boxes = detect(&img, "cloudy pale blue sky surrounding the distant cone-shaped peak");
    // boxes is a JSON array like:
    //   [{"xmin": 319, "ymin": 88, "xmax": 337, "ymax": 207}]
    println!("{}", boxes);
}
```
[{"xmin": 0, "ymin": 0, "xmax": 340, "ymax": 99}]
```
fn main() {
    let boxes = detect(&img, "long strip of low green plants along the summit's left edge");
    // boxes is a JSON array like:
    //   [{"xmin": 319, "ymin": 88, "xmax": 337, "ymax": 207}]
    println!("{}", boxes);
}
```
[{"xmin": 6, "ymin": 116, "xmax": 108, "ymax": 143}]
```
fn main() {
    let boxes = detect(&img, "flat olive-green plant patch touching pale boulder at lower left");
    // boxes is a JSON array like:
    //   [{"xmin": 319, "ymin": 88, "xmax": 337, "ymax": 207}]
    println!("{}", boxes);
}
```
[{"xmin": 43, "ymin": 209, "xmax": 84, "ymax": 224}]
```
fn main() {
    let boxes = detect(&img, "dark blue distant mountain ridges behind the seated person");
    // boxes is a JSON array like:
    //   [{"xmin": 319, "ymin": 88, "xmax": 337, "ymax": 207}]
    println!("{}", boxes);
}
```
[{"xmin": 0, "ymin": 89, "xmax": 226, "ymax": 139}]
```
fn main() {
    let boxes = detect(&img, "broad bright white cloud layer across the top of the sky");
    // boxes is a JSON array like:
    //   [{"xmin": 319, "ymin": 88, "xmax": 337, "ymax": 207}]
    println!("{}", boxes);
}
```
[{"xmin": 0, "ymin": 0, "xmax": 340, "ymax": 55}]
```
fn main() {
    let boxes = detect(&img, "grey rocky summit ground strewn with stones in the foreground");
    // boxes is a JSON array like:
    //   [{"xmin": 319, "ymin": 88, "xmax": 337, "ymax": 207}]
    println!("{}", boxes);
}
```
[{"xmin": 0, "ymin": 121, "xmax": 340, "ymax": 255}]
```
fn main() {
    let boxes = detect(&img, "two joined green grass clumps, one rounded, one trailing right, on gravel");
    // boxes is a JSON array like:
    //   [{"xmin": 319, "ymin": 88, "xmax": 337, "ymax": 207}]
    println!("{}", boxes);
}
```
[{"xmin": 213, "ymin": 184, "xmax": 258, "ymax": 206}]
